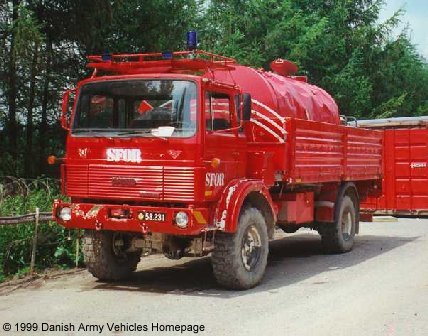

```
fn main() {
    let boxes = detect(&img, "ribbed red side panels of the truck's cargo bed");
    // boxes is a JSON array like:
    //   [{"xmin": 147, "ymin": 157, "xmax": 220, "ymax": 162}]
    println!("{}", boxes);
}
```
[{"xmin": 283, "ymin": 118, "xmax": 383, "ymax": 184}]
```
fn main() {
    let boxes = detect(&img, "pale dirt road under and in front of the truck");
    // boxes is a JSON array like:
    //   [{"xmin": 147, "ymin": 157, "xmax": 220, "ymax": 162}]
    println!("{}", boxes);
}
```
[{"xmin": 0, "ymin": 219, "xmax": 428, "ymax": 336}]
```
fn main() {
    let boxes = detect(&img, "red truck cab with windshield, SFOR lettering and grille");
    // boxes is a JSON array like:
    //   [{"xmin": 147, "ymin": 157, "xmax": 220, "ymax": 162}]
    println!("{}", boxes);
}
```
[{"xmin": 57, "ymin": 70, "xmax": 246, "ymax": 235}]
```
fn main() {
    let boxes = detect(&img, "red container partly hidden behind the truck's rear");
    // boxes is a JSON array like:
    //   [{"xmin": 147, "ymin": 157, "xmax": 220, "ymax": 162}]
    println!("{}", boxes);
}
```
[{"xmin": 358, "ymin": 117, "xmax": 428, "ymax": 215}]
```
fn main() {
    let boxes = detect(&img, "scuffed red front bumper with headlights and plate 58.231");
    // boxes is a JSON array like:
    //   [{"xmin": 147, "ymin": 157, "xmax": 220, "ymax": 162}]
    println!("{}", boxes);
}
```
[{"xmin": 52, "ymin": 200, "xmax": 209, "ymax": 236}]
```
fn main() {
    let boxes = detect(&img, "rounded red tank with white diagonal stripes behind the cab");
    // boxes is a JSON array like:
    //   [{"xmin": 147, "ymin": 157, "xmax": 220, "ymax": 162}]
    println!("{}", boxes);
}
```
[{"xmin": 205, "ymin": 62, "xmax": 340, "ymax": 143}]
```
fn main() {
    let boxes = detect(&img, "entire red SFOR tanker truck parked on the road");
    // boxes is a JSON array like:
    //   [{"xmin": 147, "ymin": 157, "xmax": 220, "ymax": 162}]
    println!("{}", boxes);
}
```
[{"xmin": 53, "ymin": 44, "xmax": 382, "ymax": 289}]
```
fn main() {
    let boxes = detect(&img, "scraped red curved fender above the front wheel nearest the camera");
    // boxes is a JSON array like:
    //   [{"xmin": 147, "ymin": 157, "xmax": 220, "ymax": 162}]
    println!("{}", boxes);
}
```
[{"xmin": 214, "ymin": 179, "xmax": 277, "ymax": 233}]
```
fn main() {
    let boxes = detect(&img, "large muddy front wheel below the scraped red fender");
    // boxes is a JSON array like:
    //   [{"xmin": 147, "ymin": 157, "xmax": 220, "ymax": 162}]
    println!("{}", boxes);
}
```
[{"xmin": 211, "ymin": 208, "xmax": 269, "ymax": 290}]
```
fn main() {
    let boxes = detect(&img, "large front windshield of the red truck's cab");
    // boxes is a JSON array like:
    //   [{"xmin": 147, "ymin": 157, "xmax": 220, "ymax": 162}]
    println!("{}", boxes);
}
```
[{"xmin": 73, "ymin": 80, "xmax": 196, "ymax": 137}]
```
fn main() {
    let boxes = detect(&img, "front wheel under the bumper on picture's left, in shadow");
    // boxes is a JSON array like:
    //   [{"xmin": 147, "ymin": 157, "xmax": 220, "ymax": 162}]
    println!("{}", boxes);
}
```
[{"xmin": 83, "ymin": 230, "xmax": 141, "ymax": 281}]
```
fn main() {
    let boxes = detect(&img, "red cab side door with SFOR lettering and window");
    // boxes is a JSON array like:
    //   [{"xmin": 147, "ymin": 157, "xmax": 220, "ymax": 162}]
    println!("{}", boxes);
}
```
[{"xmin": 203, "ymin": 89, "xmax": 246, "ymax": 200}]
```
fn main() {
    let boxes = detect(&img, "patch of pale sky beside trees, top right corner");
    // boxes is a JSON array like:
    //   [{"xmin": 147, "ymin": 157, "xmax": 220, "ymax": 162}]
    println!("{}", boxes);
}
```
[{"xmin": 380, "ymin": 0, "xmax": 428, "ymax": 60}]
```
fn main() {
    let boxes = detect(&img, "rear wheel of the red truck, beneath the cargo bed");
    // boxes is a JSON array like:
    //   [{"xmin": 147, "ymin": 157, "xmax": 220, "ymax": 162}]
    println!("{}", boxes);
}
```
[{"xmin": 319, "ymin": 196, "xmax": 357, "ymax": 253}]
